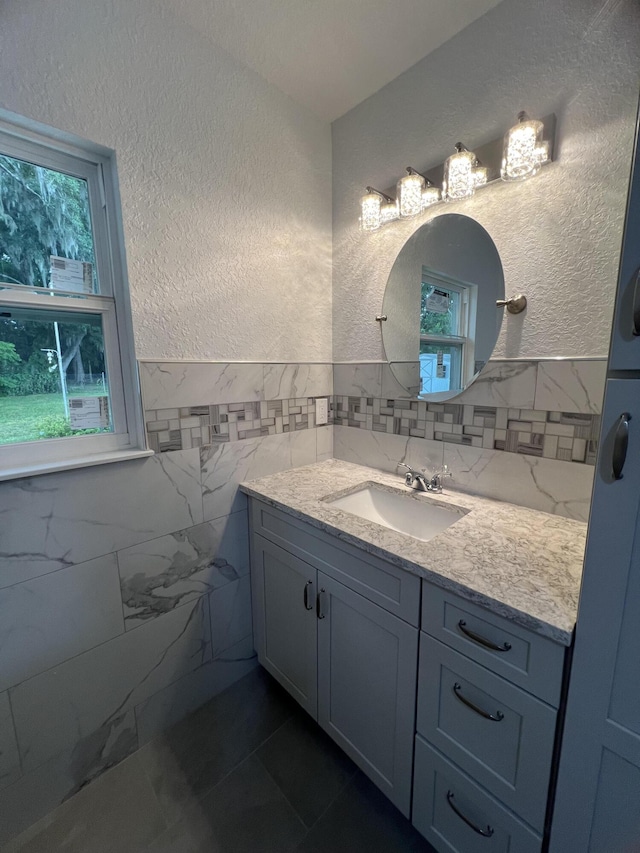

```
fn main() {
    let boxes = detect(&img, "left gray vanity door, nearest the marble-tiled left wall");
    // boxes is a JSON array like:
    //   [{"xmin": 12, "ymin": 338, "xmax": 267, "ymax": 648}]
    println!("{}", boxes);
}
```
[{"xmin": 251, "ymin": 534, "xmax": 318, "ymax": 719}]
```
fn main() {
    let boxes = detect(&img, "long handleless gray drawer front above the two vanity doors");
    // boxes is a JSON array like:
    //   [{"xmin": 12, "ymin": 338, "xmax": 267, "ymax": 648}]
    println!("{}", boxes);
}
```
[{"xmin": 251, "ymin": 499, "xmax": 420, "ymax": 626}]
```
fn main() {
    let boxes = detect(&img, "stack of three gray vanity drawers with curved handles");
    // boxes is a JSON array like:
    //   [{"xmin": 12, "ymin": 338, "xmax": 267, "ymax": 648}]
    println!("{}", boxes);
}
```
[{"xmin": 413, "ymin": 583, "xmax": 565, "ymax": 853}]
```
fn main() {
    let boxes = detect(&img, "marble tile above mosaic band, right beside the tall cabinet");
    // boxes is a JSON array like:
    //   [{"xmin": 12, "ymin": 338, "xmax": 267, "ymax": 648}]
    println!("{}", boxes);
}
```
[{"xmin": 534, "ymin": 359, "xmax": 607, "ymax": 414}]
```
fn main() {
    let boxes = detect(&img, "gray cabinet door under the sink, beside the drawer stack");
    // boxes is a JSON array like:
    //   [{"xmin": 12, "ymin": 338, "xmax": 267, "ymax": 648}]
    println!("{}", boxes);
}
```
[{"xmin": 318, "ymin": 572, "xmax": 418, "ymax": 817}]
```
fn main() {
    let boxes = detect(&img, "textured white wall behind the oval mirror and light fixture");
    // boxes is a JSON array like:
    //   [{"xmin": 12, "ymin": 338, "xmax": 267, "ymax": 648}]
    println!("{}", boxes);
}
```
[{"xmin": 333, "ymin": 0, "xmax": 640, "ymax": 361}]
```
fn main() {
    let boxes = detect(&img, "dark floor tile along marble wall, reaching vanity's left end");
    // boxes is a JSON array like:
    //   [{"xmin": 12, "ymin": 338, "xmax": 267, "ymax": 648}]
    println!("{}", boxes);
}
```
[{"xmin": 139, "ymin": 668, "xmax": 295, "ymax": 823}]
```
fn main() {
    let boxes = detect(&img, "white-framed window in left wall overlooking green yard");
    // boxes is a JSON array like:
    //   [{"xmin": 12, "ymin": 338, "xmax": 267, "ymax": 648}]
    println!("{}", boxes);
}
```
[{"xmin": 0, "ymin": 113, "xmax": 148, "ymax": 479}]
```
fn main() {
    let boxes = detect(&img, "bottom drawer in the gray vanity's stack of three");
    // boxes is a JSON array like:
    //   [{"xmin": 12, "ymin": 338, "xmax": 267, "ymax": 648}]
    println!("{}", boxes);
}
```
[{"xmin": 413, "ymin": 735, "xmax": 542, "ymax": 853}]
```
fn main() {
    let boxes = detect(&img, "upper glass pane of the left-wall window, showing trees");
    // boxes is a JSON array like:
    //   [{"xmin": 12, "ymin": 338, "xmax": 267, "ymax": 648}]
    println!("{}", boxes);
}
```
[{"xmin": 0, "ymin": 155, "xmax": 98, "ymax": 293}]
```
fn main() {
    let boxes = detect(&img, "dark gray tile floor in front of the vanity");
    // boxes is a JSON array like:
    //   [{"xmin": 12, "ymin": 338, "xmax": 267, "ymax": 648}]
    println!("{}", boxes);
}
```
[{"xmin": 2, "ymin": 668, "xmax": 435, "ymax": 853}]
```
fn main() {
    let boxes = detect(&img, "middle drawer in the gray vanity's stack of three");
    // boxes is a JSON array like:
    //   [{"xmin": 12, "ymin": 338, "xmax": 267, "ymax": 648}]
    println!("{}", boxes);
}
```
[{"xmin": 417, "ymin": 632, "xmax": 556, "ymax": 831}]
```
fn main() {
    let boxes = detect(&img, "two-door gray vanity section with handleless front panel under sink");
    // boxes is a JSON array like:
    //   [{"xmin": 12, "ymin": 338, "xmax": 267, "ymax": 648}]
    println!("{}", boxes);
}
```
[{"xmin": 251, "ymin": 500, "xmax": 420, "ymax": 817}]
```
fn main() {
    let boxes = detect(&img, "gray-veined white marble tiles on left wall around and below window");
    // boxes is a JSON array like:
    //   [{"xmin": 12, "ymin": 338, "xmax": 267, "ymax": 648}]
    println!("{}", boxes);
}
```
[{"xmin": 0, "ymin": 362, "xmax": 333, "ymax": 847}]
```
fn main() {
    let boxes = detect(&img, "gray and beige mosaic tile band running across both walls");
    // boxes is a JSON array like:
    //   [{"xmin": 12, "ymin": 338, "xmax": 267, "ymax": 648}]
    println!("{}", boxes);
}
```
[{"xmin": 145, "ymin": 396, "xmax": 600, "ymax": 465}]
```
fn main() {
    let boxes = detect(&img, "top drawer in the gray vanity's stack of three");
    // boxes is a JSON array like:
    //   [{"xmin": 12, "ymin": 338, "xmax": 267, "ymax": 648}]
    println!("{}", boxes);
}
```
[{"xmin": 422, "ymin": 581, "xmax": 565, "ymax": 708}]
